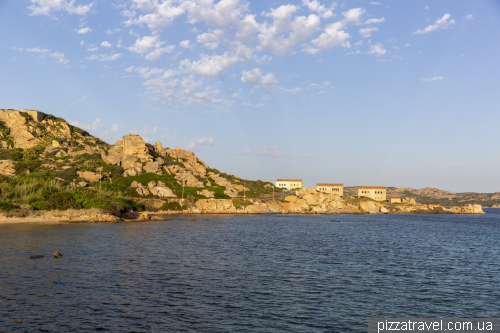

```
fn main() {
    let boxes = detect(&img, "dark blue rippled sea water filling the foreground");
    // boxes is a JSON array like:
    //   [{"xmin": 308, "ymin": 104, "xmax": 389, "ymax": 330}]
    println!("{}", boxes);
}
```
[{"xmin": 0, "ymin": 209, "xmax": 500, "ymax": 332}]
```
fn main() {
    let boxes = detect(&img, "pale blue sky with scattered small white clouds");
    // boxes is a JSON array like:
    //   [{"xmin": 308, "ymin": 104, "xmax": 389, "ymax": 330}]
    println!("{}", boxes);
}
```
[{"xmin": 0, "ymin": 0, "xmax": 500, "ymax": 192}]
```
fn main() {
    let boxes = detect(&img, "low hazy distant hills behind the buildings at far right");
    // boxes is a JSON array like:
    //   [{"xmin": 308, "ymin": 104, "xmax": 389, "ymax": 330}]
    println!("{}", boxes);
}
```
[{"xmin": 344, "ymin": 186, "xmax": 500, "ymax": 208}]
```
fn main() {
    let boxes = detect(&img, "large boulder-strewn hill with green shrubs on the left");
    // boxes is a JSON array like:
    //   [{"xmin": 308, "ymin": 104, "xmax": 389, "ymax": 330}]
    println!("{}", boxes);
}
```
[{"xmin": 0, "ymin": 109, "xmax": 280, "ymax": 210}]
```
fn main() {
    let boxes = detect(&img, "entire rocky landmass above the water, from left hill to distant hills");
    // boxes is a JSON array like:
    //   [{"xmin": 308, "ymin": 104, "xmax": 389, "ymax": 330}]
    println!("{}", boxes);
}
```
[{"xmin": 0, "ymin": 109, "xmax": 492, "ymax": 222}]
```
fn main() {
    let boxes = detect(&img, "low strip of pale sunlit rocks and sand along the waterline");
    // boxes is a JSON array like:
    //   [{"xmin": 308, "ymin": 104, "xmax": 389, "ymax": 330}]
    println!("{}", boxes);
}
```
[{"xmin": 0, "ymin": 188, "xmax": 485, "ymax": 224}]
